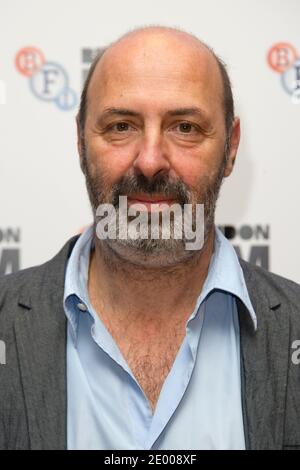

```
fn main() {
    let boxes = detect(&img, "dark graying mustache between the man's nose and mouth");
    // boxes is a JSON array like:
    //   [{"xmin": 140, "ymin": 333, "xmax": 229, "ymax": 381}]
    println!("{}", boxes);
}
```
[{"xmin": 111, "ymin": 174, "xmax": 190, "ymax": 207}]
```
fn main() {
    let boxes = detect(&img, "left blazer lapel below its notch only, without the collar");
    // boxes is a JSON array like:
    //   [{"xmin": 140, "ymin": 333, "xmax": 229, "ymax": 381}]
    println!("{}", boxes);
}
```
[{"xmin": 15, "ymin": 299, "xmax": 66, "ymax": 449}]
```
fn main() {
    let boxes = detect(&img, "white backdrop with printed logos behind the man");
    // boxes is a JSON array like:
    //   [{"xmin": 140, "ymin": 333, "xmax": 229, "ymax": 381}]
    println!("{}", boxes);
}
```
[{"xmin": 0, "ymin": 0, "xmax": 300, "ymax": 282}]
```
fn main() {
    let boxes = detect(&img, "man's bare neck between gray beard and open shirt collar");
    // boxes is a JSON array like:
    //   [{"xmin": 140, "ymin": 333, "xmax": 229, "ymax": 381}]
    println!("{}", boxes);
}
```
[{"xmin": 88, "ymin": 227, "xmax": 214, "ymax": 322}]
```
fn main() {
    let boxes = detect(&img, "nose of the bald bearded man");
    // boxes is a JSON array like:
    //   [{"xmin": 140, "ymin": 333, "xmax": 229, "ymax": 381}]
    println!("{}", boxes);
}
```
[{"xmin": 133, "ymin": 130, "xmax": 170, "ymax": 179}]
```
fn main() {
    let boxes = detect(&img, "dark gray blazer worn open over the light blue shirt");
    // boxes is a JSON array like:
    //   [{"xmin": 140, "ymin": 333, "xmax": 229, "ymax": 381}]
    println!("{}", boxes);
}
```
[{"xmin": 0, "ymin": 237, "xmax": 300, "ymax": 449}]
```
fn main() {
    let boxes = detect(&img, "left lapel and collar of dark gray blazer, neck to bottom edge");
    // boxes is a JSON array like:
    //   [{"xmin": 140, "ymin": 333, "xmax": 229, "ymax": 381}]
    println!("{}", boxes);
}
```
[{"xmin": 15, "ymin": 238, "xmax": 77, "ymax": 449}]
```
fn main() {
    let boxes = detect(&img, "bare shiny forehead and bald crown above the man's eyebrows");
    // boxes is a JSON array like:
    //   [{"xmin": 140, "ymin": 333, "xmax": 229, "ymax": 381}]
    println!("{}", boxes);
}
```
[{"xmin": 88, "ymin": 33, "xmax": 223, "ymax": 117}]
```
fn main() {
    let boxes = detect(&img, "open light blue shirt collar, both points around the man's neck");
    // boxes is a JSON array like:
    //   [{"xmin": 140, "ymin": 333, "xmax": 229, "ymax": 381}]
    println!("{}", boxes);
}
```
[{"xmin": 64, "ymin": 225, "xmax": 257, "ymax": 342}]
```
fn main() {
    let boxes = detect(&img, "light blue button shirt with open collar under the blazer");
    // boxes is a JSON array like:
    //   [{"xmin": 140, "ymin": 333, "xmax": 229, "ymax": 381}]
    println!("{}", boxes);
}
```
[{"xmin": 64, "ymin": 227, "xmax": 256, "ymax": 450}]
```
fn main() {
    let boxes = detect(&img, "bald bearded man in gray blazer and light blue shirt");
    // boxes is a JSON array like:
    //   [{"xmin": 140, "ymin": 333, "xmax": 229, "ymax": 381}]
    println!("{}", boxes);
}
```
[{"xmin": 0, "ymin": 27, "xmax": 300, "ymax": 450}]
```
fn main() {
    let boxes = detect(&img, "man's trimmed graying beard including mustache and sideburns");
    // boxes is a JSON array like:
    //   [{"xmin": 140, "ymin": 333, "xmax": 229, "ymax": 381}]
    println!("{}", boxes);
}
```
[{"xmin": 83, "ymin": 151, "xmax": 226, "ymax": 268}]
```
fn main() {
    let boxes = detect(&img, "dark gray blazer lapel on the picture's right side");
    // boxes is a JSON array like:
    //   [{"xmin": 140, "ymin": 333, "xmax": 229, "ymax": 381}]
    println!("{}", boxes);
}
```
[{"xmin": 238, "ymin": 263, "xmax": 290, "ymax": 450}]
